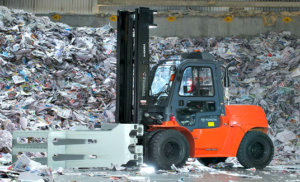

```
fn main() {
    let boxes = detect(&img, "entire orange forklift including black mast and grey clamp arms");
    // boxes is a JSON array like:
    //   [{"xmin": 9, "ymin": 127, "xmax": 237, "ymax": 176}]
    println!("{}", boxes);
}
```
[{"xmin": 13, "ymin": 7, "xmax": 274, "ymax": 169}]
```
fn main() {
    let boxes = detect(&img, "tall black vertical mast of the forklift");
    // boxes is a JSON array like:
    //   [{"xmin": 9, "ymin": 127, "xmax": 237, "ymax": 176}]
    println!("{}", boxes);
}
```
[{"xmin": 116, "ymin": 7, "xmax": 155, "ymax": 124}]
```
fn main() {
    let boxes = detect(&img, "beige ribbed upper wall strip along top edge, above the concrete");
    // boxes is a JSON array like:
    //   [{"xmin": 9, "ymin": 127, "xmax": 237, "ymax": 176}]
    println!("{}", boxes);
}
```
[{"xmin": 0, "ymin": 0, "xmax": 300, "ymax": 15}]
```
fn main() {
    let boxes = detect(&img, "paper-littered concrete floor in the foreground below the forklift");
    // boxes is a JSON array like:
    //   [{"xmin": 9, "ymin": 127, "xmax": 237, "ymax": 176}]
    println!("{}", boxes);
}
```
[{"xmin": 54, "ymin": 165, "xmax": 300, "ymax": 182}]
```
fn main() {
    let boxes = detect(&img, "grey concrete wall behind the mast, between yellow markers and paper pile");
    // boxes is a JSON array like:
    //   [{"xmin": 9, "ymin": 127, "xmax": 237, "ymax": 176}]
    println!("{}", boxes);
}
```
[{"xmin": 37, "ymin": 15, "xmax": 300, "ymax": 37}]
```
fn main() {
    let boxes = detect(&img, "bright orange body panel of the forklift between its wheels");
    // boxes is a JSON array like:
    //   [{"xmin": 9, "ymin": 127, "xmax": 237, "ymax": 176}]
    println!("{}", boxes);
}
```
[{"xmin": 149, "ymin": 105, "xmax": 268, "ymax": 158}]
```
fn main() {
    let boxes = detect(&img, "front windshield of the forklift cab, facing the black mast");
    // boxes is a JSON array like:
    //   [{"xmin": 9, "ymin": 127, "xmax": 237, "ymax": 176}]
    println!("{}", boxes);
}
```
[{"xmin": 150, "ymin": 61, "xmax": 179, "ymax": 96}]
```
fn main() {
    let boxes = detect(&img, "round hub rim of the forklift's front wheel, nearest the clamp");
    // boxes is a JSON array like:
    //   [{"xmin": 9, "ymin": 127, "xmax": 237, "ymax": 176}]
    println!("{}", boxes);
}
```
[{"xmin": 163, "ymin": 141, "xmax": 181, "ymax": 161}]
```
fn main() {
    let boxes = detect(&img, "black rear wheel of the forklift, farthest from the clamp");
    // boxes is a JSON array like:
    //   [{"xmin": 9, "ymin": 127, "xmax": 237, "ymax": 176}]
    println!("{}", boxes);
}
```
[{"xmin": 237, "ymin": 131, "xmax": 274, "ymax": 169}]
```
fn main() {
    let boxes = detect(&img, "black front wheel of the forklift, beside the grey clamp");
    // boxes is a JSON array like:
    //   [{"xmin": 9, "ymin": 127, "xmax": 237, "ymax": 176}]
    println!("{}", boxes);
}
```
[{"xmin": 149, "ymin": 130, "xmax": 190, "ymax": 169}]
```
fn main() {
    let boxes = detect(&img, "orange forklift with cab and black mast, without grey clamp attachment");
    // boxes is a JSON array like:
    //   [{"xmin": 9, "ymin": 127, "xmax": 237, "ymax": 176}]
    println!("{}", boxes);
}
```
[{"xmin": 116, "ymin": 8, "xmax": 274, "ymax": 169}]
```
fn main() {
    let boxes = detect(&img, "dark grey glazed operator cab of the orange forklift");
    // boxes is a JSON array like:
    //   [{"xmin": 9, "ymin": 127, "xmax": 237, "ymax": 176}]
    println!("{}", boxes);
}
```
[{"xmin": 145, "ymin": 52, "xmax": 224, "ymax": 131}]
